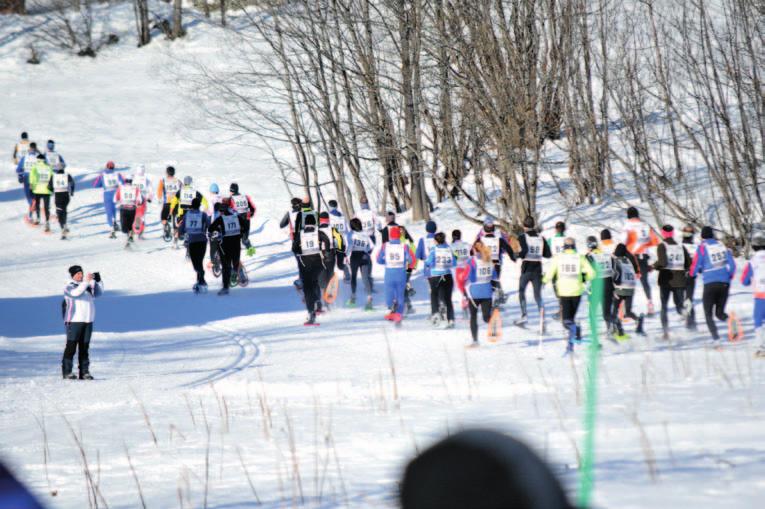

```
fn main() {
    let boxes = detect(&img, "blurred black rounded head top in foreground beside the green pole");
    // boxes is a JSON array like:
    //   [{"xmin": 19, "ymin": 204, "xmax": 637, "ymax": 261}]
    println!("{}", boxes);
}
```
[{"xmin": 400, "ymin": 430, "xmax": 573, "ymax": 509}]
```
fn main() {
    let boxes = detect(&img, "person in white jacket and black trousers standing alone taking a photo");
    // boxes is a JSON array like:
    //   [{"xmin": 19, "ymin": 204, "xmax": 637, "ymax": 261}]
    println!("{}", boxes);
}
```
[{"xmin": 61, "ymin": 265, "xmax": 104, "ymax": 380}]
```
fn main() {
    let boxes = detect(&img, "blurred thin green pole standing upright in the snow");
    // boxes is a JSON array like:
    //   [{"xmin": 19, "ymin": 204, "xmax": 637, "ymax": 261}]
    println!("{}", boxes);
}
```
[{"xmin": 577, "ymin": 266, "xmax": 603, "ymax": 508}]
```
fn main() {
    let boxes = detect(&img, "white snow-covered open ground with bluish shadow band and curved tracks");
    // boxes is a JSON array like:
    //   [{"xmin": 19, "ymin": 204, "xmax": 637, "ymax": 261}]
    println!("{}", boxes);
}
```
[{"xmin": 0, "ymin": 4, "xmax": 765, "ymax": 508}]
